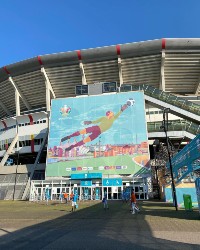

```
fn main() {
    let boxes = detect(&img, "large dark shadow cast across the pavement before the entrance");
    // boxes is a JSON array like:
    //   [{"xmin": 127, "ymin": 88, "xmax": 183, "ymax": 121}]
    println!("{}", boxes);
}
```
[{"xmin": 0, "ymin": 201, "xmax": 199, "ymax": 250}]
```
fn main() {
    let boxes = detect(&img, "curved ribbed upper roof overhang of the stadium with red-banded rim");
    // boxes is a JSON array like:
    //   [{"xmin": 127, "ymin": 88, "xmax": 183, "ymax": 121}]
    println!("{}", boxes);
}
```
[{"xmin": 0, "ymin": 38, "xmax": 200, "ymax": 118}]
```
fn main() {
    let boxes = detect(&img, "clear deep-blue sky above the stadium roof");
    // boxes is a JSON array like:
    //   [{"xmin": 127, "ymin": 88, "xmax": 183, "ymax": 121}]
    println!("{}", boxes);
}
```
[{"xmin": 0, "ymin": 0, "xmax": 200, "ymax": 67}]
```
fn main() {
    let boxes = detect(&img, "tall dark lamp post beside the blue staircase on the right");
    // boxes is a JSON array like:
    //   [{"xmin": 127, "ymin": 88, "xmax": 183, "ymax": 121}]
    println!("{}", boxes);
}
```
[{"xmin": 161, "ymin": 108, "xmax": 178, "ymax": 211}]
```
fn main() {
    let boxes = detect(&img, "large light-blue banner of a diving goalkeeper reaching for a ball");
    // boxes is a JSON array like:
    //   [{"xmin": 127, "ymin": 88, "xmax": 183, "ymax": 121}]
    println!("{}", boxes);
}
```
[{"xmin": 46, "ymin": 92, "xmax": 149, "ymax": 176}]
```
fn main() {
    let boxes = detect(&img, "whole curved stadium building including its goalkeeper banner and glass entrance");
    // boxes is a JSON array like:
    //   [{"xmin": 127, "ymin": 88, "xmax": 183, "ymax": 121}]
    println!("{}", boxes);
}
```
[{"xmin": 0, "ymin": 39, "xmax": 200, "ymax": 203}]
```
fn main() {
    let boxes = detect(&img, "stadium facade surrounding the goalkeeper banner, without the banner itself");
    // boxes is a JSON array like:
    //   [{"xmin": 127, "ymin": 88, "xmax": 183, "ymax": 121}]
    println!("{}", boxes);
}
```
[{"xmin": 0, "ymin": 39, "xmax": 200, "ymax": 202}]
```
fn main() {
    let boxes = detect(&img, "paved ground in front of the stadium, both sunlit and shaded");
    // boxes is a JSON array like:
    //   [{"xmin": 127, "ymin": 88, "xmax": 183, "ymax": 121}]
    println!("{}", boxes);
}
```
[{"xmin": 0, "ymin": 201, "xmax": 200, "ymax": 250}]
